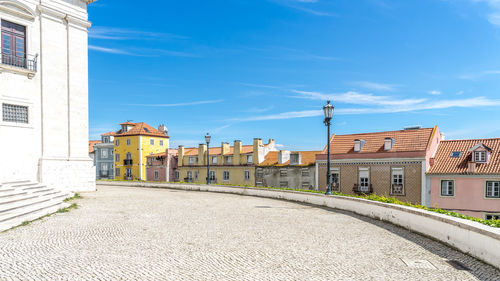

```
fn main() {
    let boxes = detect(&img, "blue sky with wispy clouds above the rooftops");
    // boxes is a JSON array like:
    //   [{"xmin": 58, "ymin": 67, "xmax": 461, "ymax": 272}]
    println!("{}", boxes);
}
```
[{"xmin": 89, "ymin": 0, "xmax": 500, "ymax": 150}]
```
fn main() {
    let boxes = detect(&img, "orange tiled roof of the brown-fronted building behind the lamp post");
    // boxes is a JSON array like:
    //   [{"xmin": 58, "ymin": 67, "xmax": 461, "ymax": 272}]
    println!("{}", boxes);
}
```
[{"xmin": 322, "ymin": 128, "xmax": 436, "ymax": 155}]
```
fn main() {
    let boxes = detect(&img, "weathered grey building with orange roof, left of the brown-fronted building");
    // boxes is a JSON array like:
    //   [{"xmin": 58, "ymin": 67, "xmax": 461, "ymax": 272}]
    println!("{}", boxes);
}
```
[{"xmin": 255, "ymin": 150, "xmax": 321, "ymax": 190}]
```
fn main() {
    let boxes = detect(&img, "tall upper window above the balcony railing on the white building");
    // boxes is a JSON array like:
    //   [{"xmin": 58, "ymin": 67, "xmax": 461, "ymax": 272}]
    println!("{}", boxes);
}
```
[{"xmin": 2, "ymin": 20, "xmax": 27, "ymax": 68}]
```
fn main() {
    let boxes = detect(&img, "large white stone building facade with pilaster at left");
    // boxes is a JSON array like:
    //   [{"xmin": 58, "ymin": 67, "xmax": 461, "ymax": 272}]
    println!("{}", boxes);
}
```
[{"xmin": 0, "ymin": 0, "xmax": 95, "ymax": 191}]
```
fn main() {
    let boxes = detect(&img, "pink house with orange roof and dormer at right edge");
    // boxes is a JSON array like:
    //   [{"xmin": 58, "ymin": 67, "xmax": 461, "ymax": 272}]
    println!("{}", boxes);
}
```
[{"xmin": 427, "ymin": 138, "xmax": 500, "ymax": 219}]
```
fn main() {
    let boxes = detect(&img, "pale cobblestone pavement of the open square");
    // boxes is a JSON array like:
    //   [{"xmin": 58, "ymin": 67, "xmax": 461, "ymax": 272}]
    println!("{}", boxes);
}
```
[{"xmin": 0, "ymin": 186, "xmax": 500, "ymax": 281}]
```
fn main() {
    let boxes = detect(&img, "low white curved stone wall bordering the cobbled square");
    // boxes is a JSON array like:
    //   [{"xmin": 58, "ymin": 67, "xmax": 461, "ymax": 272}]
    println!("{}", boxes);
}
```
[{"xmin": 97, "ymin": 181, "xmax": 500, "ymax": 268}]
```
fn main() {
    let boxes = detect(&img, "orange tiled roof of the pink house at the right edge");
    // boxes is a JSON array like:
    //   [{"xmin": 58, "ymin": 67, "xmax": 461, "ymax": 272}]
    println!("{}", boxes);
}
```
[{"xmin": 428, "ymin": 138, "xmax": 500, "ymax": 175}]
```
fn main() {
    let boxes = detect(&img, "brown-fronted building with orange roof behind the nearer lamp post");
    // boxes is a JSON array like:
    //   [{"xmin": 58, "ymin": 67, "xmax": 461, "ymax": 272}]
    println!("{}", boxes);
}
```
[{"xmin": 316, "ymin": 126, "xmax": 441, "ymax": 203}]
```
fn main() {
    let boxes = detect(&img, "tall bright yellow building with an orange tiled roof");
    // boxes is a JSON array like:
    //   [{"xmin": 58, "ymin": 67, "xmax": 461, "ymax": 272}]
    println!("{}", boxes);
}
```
[{"xmin": 114, "ymin": 122, "xmax": 169, "ymax": 180}]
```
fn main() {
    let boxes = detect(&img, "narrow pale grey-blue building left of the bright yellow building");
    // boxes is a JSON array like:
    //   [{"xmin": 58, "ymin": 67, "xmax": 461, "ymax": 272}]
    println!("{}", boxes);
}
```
[{"xmin": 94, "ymin": 132, "xmax": 115, "ymax": 179}]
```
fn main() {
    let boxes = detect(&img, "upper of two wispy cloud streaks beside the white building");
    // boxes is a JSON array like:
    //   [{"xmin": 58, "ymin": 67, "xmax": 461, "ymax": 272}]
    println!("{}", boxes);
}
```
[{"xmin": 89, "ymin": 26, "xmax": 188, "ymax": 40}]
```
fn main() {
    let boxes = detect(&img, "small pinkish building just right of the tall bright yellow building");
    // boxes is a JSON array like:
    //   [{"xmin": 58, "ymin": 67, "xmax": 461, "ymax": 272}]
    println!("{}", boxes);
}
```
[{"xmin": 146, "ymin": 149, "xmax": 179, "ymax": 181}]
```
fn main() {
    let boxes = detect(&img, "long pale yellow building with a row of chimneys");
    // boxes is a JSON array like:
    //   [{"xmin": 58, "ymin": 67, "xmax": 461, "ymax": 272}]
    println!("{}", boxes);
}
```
[{"xmin": 177, "ymin": 139, "xmax": 276, "ymax": 186}]
